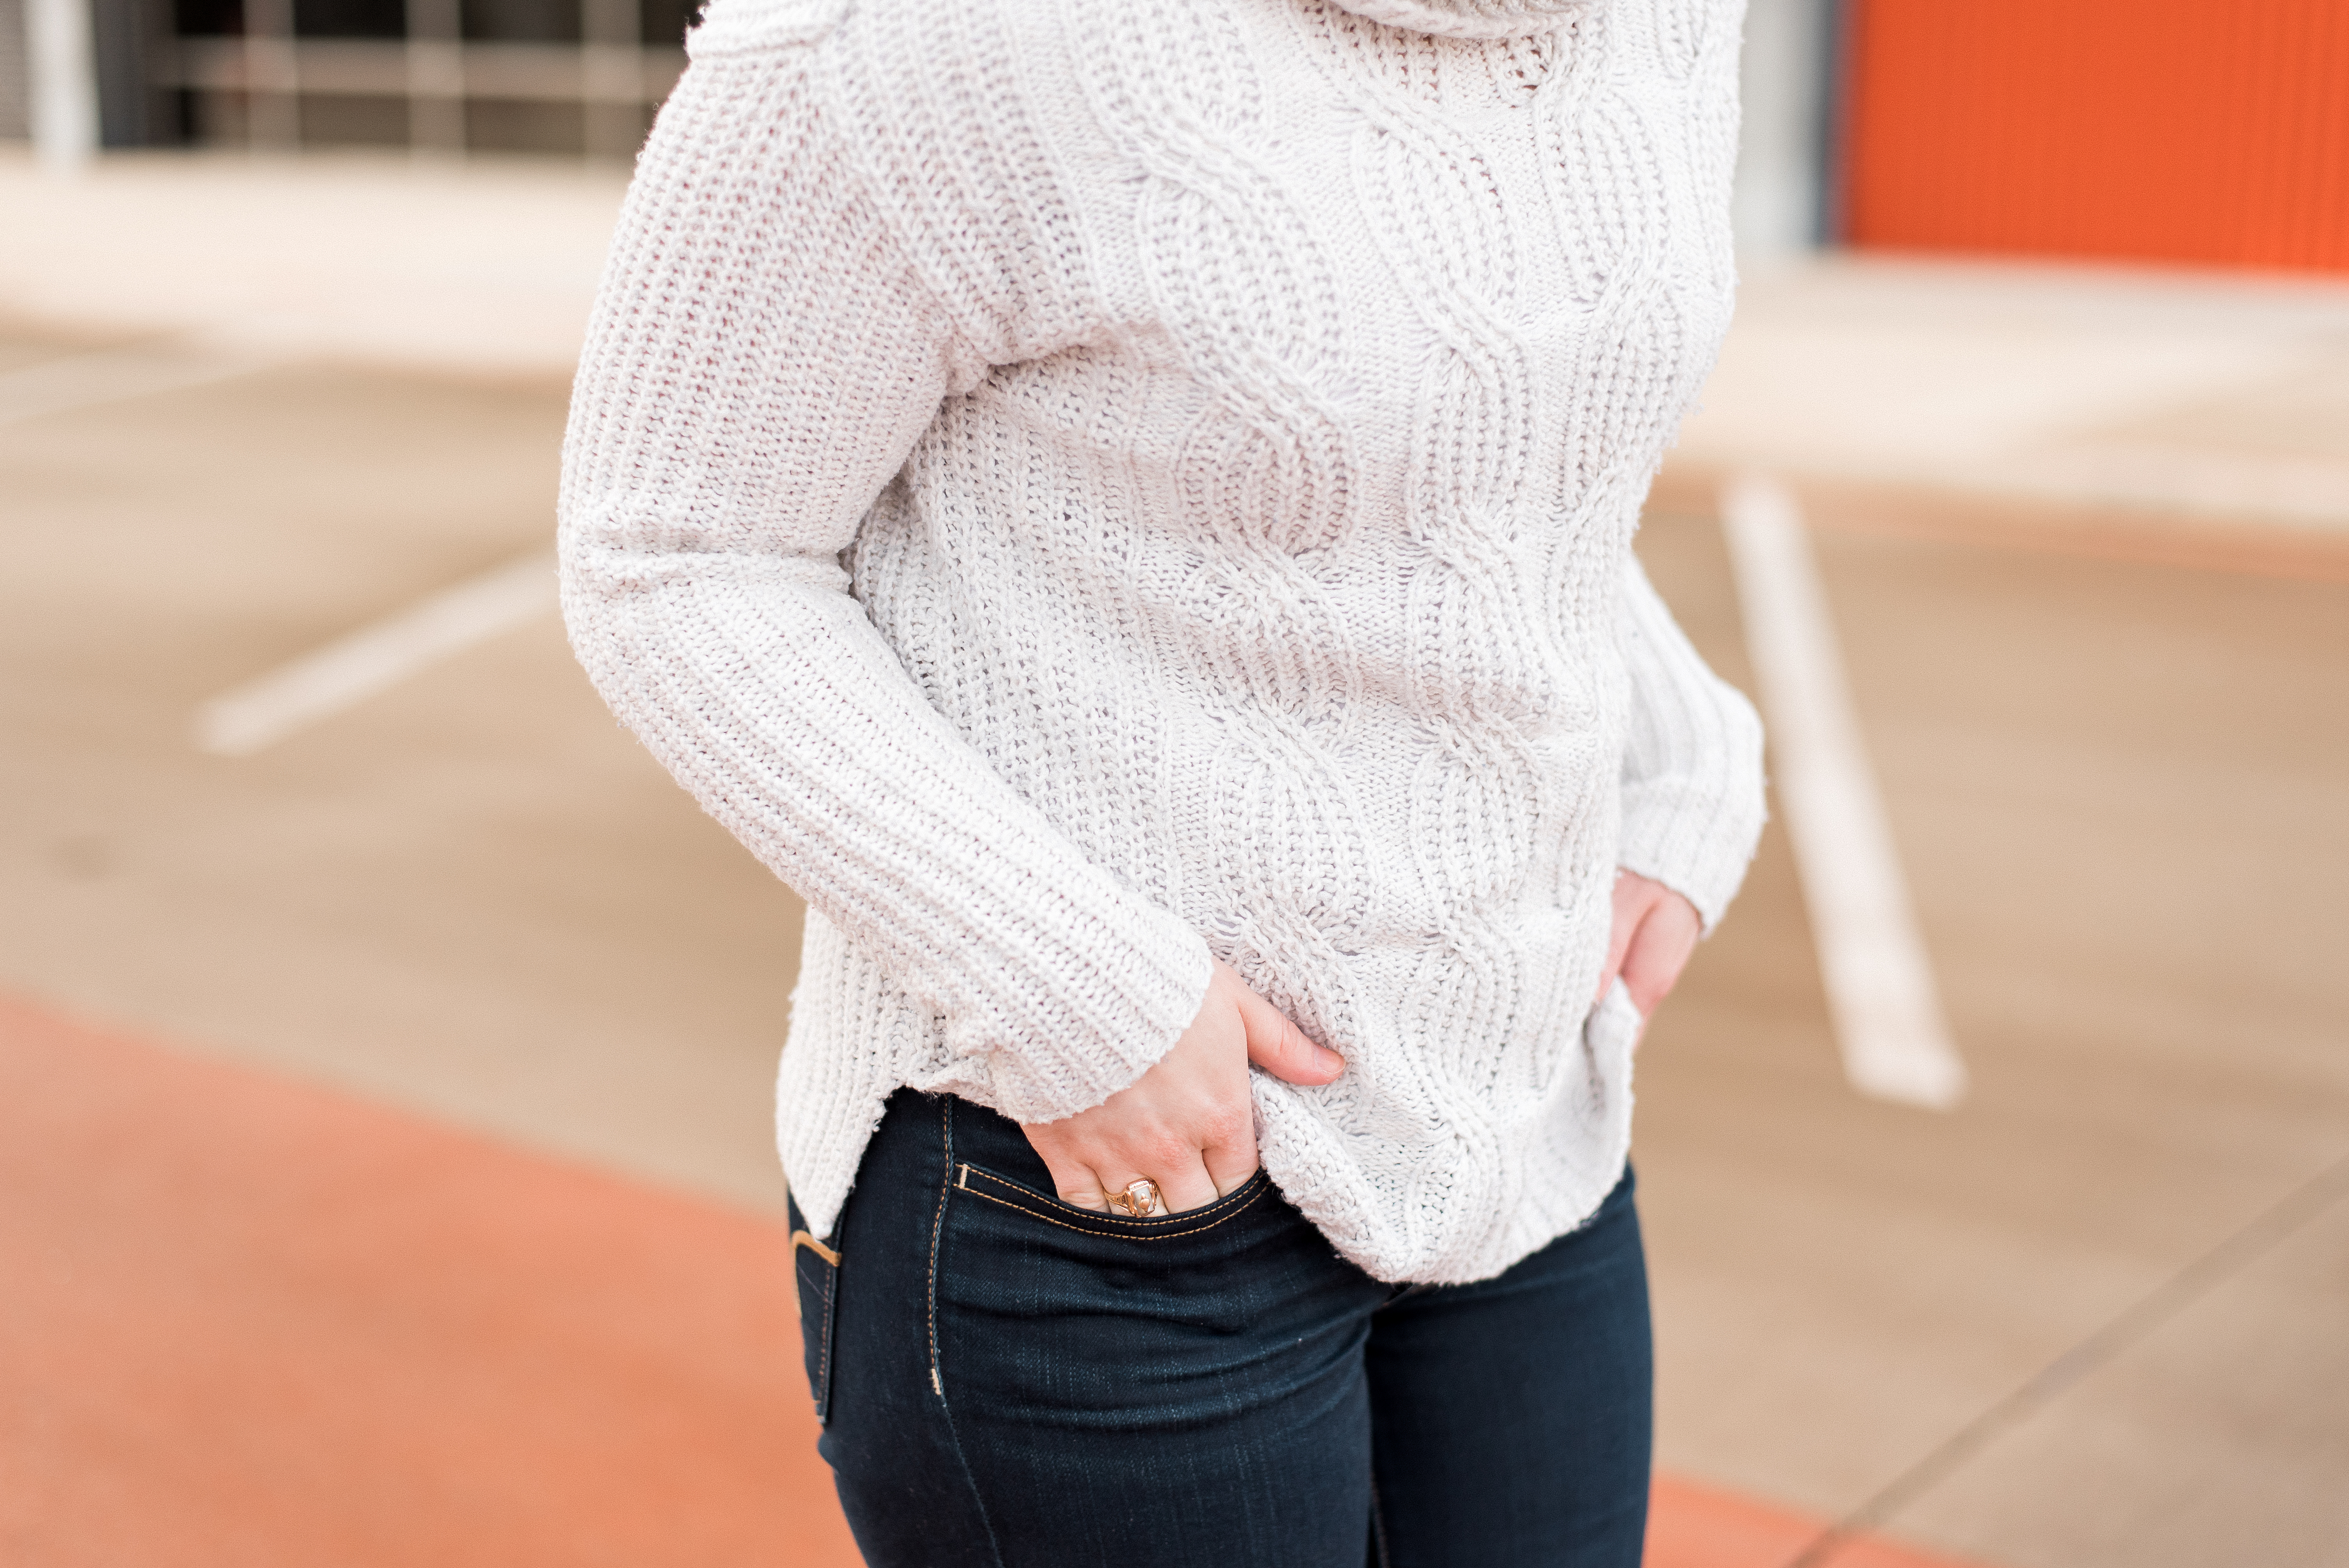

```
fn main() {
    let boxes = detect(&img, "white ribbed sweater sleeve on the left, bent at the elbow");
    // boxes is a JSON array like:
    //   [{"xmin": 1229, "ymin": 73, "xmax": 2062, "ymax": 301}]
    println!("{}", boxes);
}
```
[{"xmin": 561, "ymin": 24, "xmax": 1210, "ymax": 1120}]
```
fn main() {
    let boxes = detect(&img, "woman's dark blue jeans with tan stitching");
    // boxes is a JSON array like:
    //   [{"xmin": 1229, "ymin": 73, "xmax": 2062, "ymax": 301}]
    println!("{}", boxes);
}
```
[{"xmin": 791, "ymin": 1089, "xmax": 1651, "ymax": 1568}]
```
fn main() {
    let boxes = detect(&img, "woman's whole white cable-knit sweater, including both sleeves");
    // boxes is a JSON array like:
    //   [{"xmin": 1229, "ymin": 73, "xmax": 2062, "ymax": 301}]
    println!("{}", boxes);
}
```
[{"xmin": 561, "ymin": 0, "xmax": 1762, "ymax": 1279}]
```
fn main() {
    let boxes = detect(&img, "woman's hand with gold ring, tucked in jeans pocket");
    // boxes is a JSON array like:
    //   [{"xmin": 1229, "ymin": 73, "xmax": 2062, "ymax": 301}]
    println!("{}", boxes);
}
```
[{"xmin": 1019, "ymin": 962, "xmax": 1346, "ymax": 1211}]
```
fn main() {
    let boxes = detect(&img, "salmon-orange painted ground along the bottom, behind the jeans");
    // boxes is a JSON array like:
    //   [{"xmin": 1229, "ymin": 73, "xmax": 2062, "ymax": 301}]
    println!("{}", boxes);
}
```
[{"xmin": 0, "ymin": 998, "xmax": 1992, "ymax": 1568}]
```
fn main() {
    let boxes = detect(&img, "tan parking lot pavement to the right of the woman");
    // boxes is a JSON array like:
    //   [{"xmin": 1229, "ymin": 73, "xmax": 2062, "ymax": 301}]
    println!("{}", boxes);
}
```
[{"xmin": 1637, "ymin": 500, "xmax": 2349, "ymax": 1568}]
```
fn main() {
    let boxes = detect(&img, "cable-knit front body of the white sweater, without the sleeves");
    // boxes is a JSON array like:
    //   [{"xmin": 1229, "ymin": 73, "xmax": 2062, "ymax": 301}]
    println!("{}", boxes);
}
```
[{"xmin": 787, "ymin": 0, "xmax": 1741, "ymax": 1277}]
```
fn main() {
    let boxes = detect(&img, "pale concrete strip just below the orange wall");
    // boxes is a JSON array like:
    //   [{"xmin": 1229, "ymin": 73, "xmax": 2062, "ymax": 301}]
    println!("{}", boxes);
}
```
[{"xmin": 1675, "ymin": 256, "xmax": 2349, "ymax": 540}]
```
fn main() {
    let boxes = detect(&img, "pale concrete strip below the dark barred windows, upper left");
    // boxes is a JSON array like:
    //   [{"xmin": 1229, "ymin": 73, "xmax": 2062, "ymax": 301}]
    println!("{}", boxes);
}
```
[{"xmin": 0, "ymin": 148, "xmax": 627, "ymax": 376}]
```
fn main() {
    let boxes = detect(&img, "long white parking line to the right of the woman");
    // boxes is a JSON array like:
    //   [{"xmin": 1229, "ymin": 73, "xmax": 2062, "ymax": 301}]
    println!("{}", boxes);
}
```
[{"xmin": 1722, "ymin": 474, "xmax": 1966, "ymax": 1110}]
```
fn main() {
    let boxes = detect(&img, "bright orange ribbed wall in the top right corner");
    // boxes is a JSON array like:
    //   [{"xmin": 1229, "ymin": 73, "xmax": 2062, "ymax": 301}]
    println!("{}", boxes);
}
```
[{"xmin": 1842, "ymin": 0, "xmax": 2349, "ymax": 272}]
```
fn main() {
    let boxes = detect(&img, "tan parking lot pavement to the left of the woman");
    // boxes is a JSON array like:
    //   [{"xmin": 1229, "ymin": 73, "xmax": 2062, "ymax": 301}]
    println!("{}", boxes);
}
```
[{"xmin": 0, "ymin": 328, "xmax": 798, "ymax": 1209}]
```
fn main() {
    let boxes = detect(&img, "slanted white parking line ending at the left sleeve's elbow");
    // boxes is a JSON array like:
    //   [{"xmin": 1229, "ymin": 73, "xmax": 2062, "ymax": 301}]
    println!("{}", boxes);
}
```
[{"xmin": 195, "ymin": 554, "xmax": 554, "ymax": 756}]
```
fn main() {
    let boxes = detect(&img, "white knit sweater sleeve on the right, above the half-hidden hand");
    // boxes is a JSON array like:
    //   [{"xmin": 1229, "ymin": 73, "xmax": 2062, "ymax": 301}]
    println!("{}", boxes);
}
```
[{"xmin": 1616, "ymin": 552, "xmax": 1766, "ymax": 932}]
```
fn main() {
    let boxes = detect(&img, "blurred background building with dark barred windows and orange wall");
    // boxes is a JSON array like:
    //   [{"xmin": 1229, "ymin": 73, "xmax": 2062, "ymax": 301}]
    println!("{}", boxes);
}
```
[{"xmin": 0, "ymin": 0, "xmax": 2349, "ymax": 270}]
